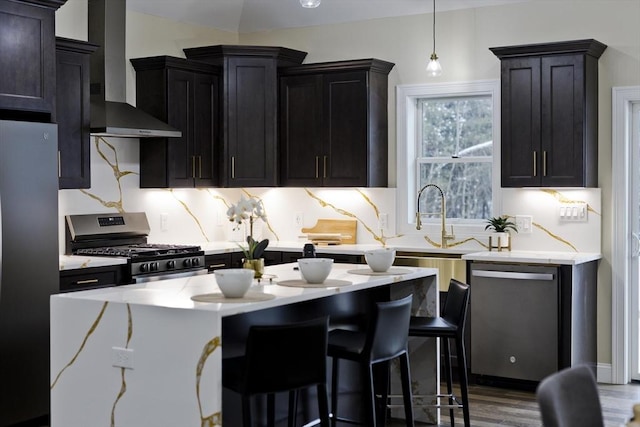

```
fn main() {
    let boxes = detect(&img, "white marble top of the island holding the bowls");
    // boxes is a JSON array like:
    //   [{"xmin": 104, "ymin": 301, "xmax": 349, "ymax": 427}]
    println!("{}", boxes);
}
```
[{"xmin": 52, "ymin": 263, "xmax": 438, "ymax": 316}]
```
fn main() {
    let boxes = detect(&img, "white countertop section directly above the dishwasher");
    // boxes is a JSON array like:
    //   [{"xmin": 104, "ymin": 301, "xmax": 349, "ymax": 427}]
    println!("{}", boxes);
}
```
[{"xmin": 462, "ymin": 251, "xmax": 602, "ymax": 265}]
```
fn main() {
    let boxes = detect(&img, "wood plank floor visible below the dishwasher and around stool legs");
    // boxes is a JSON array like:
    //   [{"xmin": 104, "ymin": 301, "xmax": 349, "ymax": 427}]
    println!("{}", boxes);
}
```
[{"xmin": 388, "ymin": 383, "xmax": 640, "ymax": 427}]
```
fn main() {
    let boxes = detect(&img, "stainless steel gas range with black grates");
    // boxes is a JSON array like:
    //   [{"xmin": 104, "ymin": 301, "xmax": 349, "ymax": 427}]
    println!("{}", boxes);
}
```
[{"xmin": 65, "ymin": 212, "xmax": 207, "ymax": 283}]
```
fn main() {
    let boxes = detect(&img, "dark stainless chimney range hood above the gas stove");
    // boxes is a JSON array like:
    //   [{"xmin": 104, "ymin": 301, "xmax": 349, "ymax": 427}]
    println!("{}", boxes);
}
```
[{"xmin": 89, "ymin": 0, "xmax": 182, "ymax": 138}]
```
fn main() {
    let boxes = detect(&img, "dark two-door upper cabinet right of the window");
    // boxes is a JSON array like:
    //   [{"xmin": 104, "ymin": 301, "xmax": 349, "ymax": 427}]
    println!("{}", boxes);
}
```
[{"xmin": 490, "ymin": 39, "xmax": 606, "ymax": 187}]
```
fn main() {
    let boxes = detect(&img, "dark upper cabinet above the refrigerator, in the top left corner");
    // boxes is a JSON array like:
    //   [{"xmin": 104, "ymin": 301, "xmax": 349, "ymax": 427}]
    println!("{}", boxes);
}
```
[{"xmin": 0, "ymin": 0, "xmax": 66, "ymax": 122}]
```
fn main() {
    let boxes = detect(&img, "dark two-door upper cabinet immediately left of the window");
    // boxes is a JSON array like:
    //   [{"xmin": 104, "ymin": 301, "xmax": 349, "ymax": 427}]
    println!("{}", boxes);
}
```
[{"xmin": 279, "ymin": 59, "xmax": 394, "ymax": 187}]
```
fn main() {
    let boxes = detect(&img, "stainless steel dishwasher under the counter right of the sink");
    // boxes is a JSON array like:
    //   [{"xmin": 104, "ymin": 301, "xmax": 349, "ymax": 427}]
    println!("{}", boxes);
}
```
[{"xmin": 470, "ymin": 262, "xmax": 559, "ymax": 381}]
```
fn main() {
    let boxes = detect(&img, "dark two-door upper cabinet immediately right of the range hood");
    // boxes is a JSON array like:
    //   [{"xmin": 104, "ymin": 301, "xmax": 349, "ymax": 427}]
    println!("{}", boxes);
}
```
[{"xmin": 131, "ymin": 56, "xmax": 220, "ymax": 188}]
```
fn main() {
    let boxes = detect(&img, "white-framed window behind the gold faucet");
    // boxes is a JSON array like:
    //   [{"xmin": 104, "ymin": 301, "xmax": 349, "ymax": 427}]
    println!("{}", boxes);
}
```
[{"xmin": 397, "ymin": 81, "xmax": 500, "ymax": 233}]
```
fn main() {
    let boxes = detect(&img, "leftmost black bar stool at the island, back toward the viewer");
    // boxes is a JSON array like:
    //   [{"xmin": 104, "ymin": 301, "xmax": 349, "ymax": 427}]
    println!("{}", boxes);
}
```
[{"xmin": 222, "ymin": 317, "xmax": 329, "ymax": 427}]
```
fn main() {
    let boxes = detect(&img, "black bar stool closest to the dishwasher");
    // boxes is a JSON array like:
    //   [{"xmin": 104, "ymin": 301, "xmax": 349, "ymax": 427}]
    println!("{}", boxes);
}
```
[{"xmin": 409, "ymin": 279, "xmax": 471, "ymax": 427}]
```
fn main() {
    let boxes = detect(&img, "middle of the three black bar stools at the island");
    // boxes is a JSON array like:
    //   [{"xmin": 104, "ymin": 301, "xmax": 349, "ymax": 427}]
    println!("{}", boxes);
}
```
[{"xmin": 328, "ymin": 295, "xmax": 414, "ymax": 427}]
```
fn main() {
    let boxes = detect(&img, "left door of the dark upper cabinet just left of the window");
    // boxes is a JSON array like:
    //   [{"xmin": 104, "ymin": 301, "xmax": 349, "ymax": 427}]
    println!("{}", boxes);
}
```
[{"xmin": 279, "ymin": 75, "xmax": 325, "ymax": 187}]
